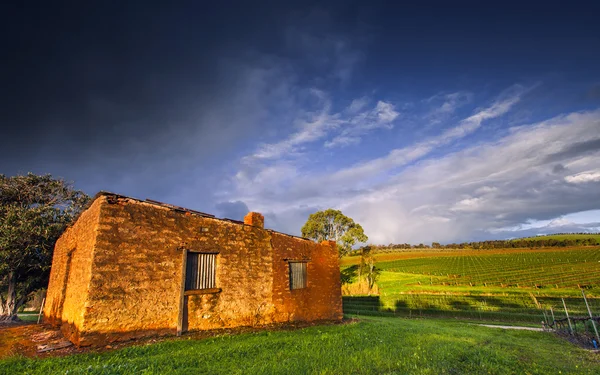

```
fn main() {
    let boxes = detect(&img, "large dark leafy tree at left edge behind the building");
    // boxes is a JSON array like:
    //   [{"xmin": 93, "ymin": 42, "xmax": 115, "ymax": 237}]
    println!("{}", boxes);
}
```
[{"xmin": 0, "ymin": 173, "xmax": 89, "ymax": 320}]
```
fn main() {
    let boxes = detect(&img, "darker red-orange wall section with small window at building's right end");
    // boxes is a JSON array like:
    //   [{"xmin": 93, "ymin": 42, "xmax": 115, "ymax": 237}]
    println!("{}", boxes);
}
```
[{"xmin": 272, "ymin": 233, "xmax": 343, "ymax": 321}]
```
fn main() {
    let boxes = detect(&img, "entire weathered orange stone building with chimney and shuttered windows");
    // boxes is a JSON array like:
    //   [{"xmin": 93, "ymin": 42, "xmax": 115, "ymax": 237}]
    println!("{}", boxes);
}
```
[{"xmin": 44, "ymin": 192, "xmax": 342, "ymax": 346}]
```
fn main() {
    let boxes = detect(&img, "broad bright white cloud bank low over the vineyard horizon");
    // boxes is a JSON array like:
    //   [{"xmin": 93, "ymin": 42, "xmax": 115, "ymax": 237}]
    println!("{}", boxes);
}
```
[{"xmin": 340, "ymin": 111, "xmax": 600, "ymax": 243}]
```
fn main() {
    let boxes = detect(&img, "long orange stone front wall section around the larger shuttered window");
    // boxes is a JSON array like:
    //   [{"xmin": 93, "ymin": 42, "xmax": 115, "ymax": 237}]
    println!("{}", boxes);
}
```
[{"xmin": 80, "ymin": 197, "xmax": 273, "ymax": 345}]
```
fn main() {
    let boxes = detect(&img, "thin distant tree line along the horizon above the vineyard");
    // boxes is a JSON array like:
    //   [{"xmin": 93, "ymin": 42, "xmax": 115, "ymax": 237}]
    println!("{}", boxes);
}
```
[{"xmin": 351, "ymin": 233, "xmax": 600, "ymax": 255}]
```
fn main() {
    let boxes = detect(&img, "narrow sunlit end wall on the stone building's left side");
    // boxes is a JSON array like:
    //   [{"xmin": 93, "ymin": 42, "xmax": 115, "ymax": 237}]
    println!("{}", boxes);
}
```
[{"xmin": 44, "ymin": 201, "xmax": 100, "ymax": 341}]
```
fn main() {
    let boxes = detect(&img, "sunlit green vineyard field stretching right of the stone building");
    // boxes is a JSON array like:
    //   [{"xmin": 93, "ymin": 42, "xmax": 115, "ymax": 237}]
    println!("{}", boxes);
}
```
[{"xmin": 343, "ymin": 247, "xmax": 600, "ymax": 323}]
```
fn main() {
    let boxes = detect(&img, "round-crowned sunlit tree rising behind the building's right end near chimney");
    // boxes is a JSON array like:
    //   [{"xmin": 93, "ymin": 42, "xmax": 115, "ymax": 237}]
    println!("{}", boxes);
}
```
[{"xmin": 302, "ymin": 208, "xmax": 369, "ymax": 257}]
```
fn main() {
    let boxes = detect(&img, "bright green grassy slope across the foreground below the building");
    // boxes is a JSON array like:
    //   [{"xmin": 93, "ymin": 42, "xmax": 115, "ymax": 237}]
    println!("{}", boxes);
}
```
[{"xmin": 0, "ymin": 318, "xmax": 600, "ymax": 374}]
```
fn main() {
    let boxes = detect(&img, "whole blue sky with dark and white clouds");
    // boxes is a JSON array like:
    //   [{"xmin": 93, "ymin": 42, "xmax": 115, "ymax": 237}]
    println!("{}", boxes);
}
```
[{"xmin": 0, "ymin": 1, "xmax": 600, "ymax": 244}]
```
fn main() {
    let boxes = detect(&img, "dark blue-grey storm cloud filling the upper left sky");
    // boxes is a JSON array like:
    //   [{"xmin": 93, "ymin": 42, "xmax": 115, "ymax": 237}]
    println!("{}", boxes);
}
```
[{"xmin": 0, "ymin": 2, "xmax": 300, "ymax": 204}]
